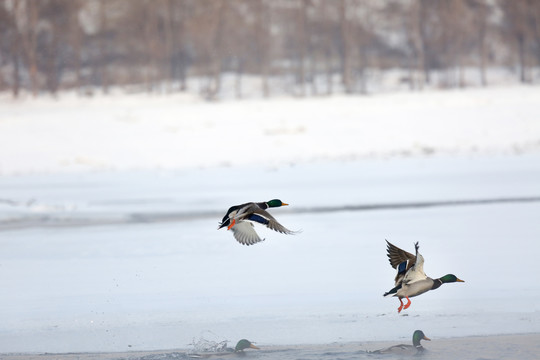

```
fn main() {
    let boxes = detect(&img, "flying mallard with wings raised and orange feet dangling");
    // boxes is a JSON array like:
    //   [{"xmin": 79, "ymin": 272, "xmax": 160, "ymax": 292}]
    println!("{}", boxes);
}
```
[{"xmin": 384, "ymin": 240, "xmax": 464, "ymax": 313}]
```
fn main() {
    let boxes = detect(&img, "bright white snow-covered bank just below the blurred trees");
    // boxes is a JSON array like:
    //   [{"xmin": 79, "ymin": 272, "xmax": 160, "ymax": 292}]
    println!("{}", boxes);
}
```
[{"xmin": 0, "ymin": 87, "xmax": 540, "ymax": 175}]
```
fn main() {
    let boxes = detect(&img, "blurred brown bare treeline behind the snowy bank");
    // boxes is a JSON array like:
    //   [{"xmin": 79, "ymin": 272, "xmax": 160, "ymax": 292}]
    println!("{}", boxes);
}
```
[{"xmin": 0, "ymin": 0, "xmax": 540, "ymax": 99}]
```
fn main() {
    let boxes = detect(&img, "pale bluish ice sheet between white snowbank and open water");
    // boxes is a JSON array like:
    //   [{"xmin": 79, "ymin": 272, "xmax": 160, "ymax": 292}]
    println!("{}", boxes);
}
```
[{"xmin": 0, "ymin": 154, "xmax": 540, "ymax": 359}]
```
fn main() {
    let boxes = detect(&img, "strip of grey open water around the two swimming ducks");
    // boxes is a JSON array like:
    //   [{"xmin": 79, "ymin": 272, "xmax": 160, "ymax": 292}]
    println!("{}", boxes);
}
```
[{"xmin": 2, "ymin": 334, "xmax": 540, "ymax": 360}]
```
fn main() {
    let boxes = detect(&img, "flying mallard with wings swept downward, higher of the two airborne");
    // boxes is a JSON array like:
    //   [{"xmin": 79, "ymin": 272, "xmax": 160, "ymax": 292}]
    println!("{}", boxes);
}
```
[{"xmin": 218, "ymin": 199, "xmax": 295, "ymax": 245}]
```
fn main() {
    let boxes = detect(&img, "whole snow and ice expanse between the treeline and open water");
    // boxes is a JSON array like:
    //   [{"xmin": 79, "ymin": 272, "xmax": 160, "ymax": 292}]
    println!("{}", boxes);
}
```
[{"xmin": 0, "ymin": 88, "xmax": 540, "ymax": 353}]
